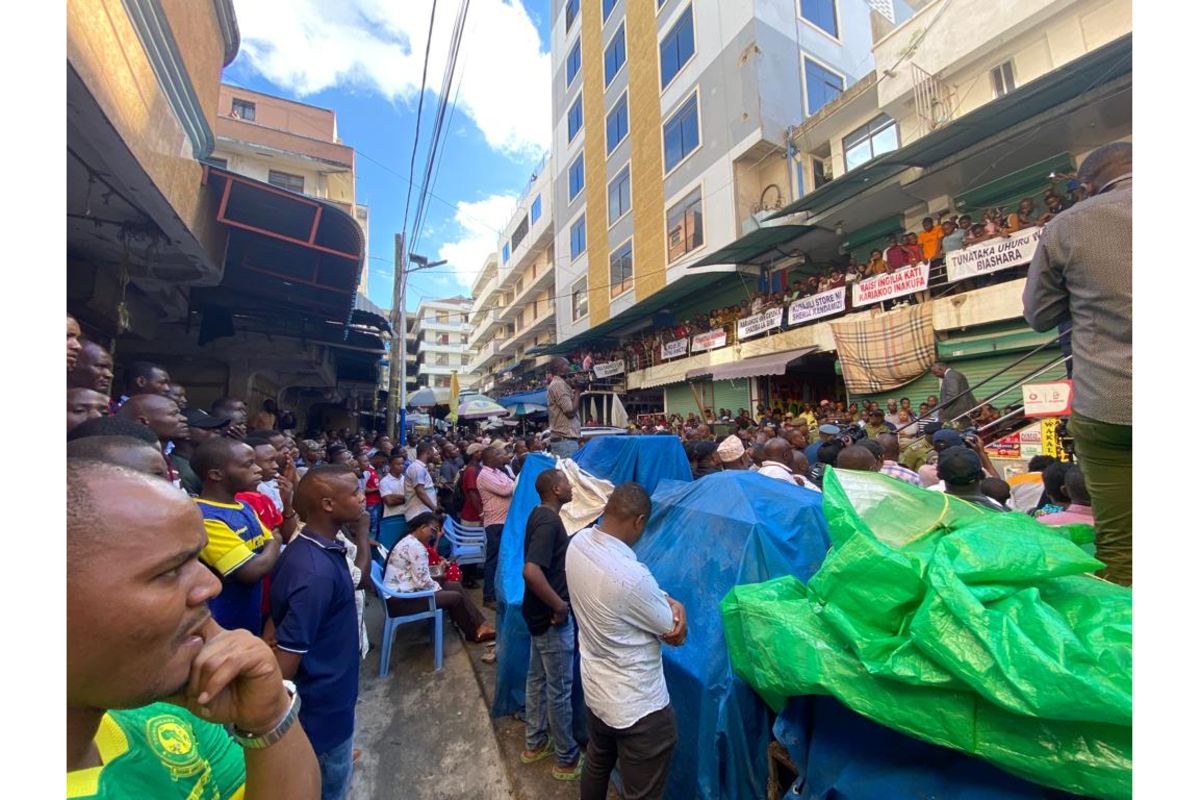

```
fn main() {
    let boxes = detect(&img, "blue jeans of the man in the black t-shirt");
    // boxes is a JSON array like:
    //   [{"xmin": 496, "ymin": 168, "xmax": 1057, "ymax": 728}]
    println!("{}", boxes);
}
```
[{"xmin": 526, "ymin": 615, "xmax": 580, "ymax": 766}]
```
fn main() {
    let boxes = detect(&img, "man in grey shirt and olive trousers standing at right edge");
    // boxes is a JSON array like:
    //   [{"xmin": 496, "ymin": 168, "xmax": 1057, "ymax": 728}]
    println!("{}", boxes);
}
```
[{"xmin": 1024, "ymin": 142, "xmax": 1133, "ymax": 585}]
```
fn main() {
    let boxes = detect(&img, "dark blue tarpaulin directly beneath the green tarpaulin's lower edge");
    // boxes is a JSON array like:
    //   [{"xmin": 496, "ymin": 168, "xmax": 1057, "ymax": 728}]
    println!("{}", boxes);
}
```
[{"xmin": 775, "ymin": 697, "xmax": 1076, "ymax": 800}]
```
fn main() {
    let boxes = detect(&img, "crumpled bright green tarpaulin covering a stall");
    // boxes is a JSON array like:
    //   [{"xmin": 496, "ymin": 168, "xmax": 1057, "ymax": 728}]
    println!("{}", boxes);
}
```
[{"xmin": 721, "ymin": 470, "xmax": 1133, "ymax": 798}]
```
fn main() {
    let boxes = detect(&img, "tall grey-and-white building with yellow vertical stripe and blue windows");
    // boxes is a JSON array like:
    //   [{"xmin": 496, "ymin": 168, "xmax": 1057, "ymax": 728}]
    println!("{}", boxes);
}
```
[{"xmin": 551, "ymin": 0, "xmax": 907, "ymax": 347}]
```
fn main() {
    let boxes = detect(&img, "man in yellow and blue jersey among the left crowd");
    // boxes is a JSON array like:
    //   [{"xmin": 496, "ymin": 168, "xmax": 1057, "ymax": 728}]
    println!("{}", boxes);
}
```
[{"xmin": 192, "ymin": 438, "xmax": 280, "ymax": 636}]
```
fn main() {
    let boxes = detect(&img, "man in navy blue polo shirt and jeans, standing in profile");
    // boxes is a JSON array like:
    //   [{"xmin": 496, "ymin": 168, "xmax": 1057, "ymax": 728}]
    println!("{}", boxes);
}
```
[{"xmin": 271, "ymin": 464, "xmax": 366, "ymax": 800}]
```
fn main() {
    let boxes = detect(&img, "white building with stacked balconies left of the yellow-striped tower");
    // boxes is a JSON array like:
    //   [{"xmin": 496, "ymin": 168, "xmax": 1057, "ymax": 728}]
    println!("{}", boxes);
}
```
[{"xmin": 468, "ymin": 158, "xmax": 556, "ymax": 396}]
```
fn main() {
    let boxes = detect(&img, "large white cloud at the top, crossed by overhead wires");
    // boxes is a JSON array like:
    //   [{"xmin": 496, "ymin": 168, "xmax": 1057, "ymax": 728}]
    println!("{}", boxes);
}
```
[{"xmin": 235, "ymin": 0, "xmax": 552, "ymax": 158}]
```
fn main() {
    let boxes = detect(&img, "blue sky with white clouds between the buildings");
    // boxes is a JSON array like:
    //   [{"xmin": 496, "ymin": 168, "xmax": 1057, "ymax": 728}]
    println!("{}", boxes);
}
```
[{"xmin": 224, "ymin": 0, "xmax": 552, "ymax": 309}]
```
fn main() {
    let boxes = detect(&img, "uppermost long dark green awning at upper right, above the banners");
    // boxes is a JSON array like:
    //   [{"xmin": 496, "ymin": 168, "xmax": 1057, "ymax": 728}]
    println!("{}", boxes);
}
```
[{"xmin": 768, "ymin": 34, "xmax": 1133, "ymax": 219}]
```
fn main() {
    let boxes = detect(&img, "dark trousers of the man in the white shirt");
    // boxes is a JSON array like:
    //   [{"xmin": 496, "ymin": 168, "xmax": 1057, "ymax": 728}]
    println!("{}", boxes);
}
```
[{"xmin": 580, "ymin": 705, "xmax": 676, "ymax": 800}]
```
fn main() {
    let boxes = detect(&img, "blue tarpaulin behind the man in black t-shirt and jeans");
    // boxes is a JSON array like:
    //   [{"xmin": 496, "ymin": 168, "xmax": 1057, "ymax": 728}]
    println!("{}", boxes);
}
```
[{"xmin": 492, "ymin": 437, "xmax": 691, "ymax": 730}]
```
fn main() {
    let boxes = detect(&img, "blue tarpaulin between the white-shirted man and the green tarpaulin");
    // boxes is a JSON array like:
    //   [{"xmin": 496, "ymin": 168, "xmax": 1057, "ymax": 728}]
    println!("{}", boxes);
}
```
[{"xmin": 634, "ymin": 471, "xmax": 829, "ymax": 800}]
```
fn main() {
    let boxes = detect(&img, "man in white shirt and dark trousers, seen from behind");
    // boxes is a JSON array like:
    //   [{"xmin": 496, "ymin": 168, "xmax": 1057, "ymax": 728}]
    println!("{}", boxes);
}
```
[{"xmin": 566, "ymin": 482, "xmax": 688, "ymax": 800}]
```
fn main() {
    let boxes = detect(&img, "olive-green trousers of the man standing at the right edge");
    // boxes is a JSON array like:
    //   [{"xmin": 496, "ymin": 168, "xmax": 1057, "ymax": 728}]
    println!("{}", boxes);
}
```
[{"xmin": 1070, "ymin": 413, "xmax": 1133, "ymax": 587}]
